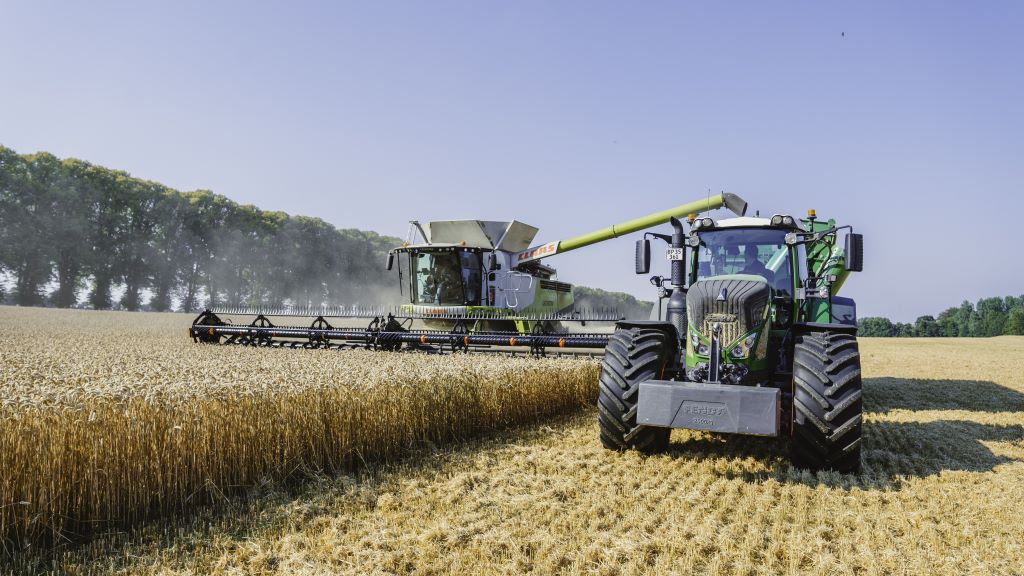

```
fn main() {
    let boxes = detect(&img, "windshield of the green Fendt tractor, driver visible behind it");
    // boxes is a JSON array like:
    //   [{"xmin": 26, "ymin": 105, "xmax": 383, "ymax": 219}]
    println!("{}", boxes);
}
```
[{"xmin": 696, "ymin": 229, "xmax": 793, "ymax": 294}]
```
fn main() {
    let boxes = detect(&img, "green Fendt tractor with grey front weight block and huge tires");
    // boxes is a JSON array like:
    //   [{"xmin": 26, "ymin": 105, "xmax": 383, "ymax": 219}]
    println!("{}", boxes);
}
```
[{"xmin": 597, "ymin": 201, "xmax": 863, "ymax": 472}]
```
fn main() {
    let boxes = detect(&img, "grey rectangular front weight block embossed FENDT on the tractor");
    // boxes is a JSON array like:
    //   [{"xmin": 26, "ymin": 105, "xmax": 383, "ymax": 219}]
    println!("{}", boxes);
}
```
[{"xmin": 637, "ymin": 380, "xmax": 781, "ymax": 436}]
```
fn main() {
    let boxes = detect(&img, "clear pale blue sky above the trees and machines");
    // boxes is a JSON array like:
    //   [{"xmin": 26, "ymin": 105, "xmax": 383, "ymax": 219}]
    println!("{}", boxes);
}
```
[{"xmin": 0, "ymin": 1, "xmax": 1024, "ymax": 321}]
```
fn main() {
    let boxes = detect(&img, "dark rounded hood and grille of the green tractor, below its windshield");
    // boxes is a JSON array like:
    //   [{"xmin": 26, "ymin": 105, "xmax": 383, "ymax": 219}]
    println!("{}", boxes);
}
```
[{"xmin": 686, "ymin": 274, "xmax": 771, "ymax": 345}]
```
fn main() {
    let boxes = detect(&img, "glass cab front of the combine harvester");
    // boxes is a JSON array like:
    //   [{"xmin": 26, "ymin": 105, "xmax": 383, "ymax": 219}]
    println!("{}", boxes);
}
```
[{"xmin": 410, "ymin": 250, "xmax": 482, "ymax": 306}]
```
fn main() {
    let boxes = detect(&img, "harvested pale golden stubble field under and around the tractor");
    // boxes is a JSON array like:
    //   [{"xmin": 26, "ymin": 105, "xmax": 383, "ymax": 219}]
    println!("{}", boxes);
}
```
[{"xmin": 3, "ymin": 307, "xmax": 1024, "ymax": 575}]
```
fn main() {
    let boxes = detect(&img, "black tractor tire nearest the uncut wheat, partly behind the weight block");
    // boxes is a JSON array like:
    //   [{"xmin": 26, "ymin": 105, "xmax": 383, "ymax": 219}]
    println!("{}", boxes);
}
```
[{"xmin": 597, "ymin": 328, "xmax": 672, "ymax": 454}]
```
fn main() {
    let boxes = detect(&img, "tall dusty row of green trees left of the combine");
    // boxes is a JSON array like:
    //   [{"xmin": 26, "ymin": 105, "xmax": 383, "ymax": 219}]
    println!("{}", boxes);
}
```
[{"xmin": 0, "ymin": 147, "xmax": 400, "ymax": 311}]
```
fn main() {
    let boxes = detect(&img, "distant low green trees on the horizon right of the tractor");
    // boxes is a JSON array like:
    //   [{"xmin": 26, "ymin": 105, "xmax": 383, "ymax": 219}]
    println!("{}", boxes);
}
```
[{"xmin": 857, "ymin": 295, "xmax": 1024, "ymax": 337}]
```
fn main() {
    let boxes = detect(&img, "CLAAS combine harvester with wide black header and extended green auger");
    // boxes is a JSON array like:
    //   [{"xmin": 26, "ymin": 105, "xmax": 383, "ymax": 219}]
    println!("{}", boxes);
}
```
[{"xmin": 188, "ymin": 194, "xmax": 746, "ymax": 355}]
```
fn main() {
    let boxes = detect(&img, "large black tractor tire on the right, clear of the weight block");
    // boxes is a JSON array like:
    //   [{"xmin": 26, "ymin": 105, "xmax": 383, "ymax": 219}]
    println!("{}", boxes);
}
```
[{"xmin": 793, "ymin": 332, "xmax": 863, "ymax": 474}]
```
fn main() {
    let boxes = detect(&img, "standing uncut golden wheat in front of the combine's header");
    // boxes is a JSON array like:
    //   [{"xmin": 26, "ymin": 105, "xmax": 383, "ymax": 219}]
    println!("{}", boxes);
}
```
[{"xmin": 0, "ymin": 307, "xmax": 598, "ymax": 553}]
